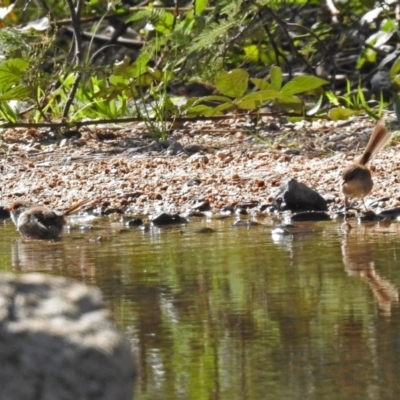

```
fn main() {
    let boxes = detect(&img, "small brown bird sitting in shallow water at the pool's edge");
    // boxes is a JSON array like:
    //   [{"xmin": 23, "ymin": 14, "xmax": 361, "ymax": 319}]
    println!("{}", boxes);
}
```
[{"xmin": 6, "ymin": 199, "xmax": 91, "ymax": 240}]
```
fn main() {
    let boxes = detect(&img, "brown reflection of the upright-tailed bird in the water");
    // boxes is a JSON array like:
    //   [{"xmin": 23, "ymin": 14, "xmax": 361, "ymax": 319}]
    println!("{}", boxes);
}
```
[{"xmin": 342, "ymin": 232, "xmax": 399, "ymax": 317}]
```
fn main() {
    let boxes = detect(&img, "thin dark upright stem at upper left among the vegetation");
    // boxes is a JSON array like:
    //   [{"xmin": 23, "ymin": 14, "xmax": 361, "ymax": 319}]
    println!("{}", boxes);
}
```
[{"xmin": 62, "ymin": 0, "xmax": 84, "ymax": 121}]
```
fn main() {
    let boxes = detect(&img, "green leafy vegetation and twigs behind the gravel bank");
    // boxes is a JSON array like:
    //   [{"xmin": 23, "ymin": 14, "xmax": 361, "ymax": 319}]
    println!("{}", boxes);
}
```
[{"xmin": 0, "ymin": 0, "xmax": 400, "ymax": 137}]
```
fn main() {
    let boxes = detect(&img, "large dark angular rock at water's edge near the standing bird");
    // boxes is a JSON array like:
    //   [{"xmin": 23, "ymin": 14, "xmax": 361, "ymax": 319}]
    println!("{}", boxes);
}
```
[{"xmin": 275, "ymin": 179, "xmax": 328, "ymax": 211}]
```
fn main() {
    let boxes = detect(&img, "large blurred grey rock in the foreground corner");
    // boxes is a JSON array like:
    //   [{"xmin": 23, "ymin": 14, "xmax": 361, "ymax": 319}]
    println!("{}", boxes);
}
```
[{"xmin": 0, "ymin": 274, "xmax": 136, "ymax": 400}]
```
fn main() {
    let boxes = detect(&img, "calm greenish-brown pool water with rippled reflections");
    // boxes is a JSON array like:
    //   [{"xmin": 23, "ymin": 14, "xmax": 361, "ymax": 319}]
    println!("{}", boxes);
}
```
[{"xmin": 0, "ymin": 216, "xmax": 400, "ymax": 400}]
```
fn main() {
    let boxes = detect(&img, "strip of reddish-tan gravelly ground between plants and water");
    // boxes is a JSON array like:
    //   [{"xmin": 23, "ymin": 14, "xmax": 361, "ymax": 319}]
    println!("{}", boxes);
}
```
[{"xmin": 0, "ymin": 114, "xmax": 400, "ymax": 214}]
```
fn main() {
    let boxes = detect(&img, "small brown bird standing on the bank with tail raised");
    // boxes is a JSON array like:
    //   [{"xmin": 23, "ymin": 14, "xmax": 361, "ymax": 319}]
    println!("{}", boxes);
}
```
[{"xmin": 342, "ymin": 119, "xmax": 392, "ymax": 208}]
